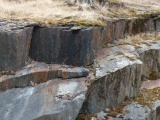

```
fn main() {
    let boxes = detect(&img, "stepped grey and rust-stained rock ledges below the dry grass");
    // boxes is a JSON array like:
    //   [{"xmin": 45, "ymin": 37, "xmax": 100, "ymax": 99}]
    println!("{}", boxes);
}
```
[{"xmin": 0, "ymin": 18, "xmax": 160, "ymax": 120}]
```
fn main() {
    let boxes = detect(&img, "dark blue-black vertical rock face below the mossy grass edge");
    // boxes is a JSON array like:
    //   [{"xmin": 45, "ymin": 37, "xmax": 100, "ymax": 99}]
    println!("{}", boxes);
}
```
[{"xmin": 30, "ymin": 27, "xmax": 100, "ymax": 66}]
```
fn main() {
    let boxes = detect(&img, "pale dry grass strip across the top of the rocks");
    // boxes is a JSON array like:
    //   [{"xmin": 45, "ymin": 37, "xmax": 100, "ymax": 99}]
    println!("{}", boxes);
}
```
[{"xmin": 0, "ymin": 0, "xmax": 160, "ymax": 26}]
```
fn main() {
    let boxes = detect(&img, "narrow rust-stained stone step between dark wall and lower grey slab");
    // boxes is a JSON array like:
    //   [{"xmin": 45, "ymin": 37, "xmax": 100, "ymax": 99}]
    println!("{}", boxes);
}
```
[{"xmin": 0, "ymin": 62, "xmax": 89, "ymax": 92}]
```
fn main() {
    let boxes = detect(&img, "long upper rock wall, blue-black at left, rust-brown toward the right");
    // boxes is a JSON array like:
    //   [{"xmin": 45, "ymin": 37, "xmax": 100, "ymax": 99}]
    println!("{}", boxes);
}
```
[{"xmin": 30, "ymin": 19, "xmax": 155, "ymax": 66}]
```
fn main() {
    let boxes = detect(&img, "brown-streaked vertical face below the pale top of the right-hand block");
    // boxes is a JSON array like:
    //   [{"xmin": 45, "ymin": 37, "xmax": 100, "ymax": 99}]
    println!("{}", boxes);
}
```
[{"xmin": 81, "ymin": 64, "xmax": 141, "ymax": 113}]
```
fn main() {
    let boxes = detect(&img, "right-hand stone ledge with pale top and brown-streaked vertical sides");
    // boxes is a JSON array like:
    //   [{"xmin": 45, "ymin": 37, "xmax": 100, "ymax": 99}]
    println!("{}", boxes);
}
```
[{"xmin": 80, "ymin": 33, "xmax": 160, "ymax": 113}]
